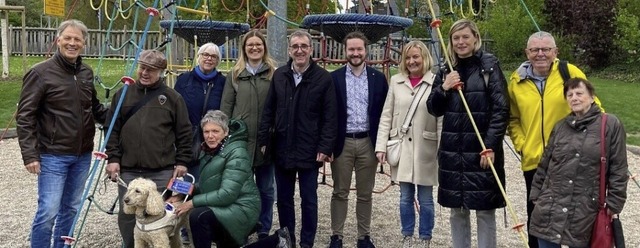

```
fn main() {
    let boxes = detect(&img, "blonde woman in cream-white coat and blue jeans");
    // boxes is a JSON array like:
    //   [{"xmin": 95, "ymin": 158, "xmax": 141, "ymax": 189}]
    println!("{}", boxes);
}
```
[{"xmin": 376, "ymin": 41, "xmax": 442, "ymax": 247}]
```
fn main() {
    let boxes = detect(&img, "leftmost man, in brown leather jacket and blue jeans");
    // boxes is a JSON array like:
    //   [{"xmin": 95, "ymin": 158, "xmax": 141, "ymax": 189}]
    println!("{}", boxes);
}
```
[{"xmin": 16, "ymin": 20, "xmax": 107, "ymax": 248}]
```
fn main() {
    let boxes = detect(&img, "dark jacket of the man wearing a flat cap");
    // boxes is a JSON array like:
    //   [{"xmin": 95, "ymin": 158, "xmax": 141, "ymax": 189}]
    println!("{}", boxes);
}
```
[{"xmin": 107, "ymin": 79, "xmax": 193, "ymax": 170}]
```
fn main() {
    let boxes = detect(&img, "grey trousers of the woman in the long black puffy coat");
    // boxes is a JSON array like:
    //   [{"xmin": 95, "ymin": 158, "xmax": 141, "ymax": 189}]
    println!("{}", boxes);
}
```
[{"xmin": 449, "ymin": 208, "xmax": 497, "ymax": 248}]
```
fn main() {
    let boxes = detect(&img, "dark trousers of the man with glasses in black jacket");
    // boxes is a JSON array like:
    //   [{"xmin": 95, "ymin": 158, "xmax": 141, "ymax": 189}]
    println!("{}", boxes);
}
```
[{"xmin": 275, "ymin": 165, "xmax": 318, "ymax": 247}]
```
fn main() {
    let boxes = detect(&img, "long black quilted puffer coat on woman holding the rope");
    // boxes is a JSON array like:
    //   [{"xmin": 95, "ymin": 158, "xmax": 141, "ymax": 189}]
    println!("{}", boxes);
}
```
[{"xmin": 427, "ymin": 51, "xmax": 509, "ymax": 210}]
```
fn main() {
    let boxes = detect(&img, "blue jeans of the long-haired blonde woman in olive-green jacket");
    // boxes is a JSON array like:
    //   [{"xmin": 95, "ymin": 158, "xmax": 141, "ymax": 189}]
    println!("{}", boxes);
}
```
[{"xmin": 255, "ymin": 164, "xmax": 275, "ymax": 234}]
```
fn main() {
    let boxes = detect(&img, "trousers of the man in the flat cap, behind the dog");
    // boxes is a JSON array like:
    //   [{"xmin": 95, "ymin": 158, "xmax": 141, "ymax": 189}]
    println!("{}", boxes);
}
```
[{"xmin": 118, "ymin": 167, "xmax": 173, "ymax": 248}]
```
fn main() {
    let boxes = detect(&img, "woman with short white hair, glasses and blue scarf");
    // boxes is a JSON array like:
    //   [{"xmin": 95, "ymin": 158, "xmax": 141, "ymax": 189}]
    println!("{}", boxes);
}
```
[{"xmin": 174, "ymin": 43, "xmax": 225, "ymax": 179}]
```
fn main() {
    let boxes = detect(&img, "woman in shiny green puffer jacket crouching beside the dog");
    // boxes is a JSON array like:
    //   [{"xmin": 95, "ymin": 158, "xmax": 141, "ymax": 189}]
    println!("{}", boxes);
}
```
[{"xmin": 169, "ymin": 110, "xmax": 288, "ymax": 248}]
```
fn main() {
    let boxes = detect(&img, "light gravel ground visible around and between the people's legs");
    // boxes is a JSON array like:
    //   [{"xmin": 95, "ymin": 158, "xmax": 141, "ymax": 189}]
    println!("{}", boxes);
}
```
[{"xmin": 0, "ymin": 131, "xmax": 640, "ymax": 247}]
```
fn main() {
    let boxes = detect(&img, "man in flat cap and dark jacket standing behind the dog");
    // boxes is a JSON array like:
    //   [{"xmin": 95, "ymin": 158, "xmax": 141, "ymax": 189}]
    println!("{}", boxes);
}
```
[{"xmin": 106, "ymin": 50, "xmax": 192, "ymax": 248}]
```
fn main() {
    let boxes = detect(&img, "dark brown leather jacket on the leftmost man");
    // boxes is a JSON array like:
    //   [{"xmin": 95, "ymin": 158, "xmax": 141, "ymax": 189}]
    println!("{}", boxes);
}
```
[{"xmin": 16, "ymin": 53, "xmax": 108, "ymax": 165}]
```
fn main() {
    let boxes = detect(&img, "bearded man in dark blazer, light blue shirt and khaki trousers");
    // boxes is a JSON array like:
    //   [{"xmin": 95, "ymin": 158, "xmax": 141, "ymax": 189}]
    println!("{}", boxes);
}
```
[{"xmin": 329, "ymin": 31, "xmax": 389, "ymax": 248}]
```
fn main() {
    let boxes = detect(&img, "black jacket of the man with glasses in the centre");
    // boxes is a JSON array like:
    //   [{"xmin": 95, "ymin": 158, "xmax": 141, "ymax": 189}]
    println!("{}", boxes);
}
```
[{"xmin": 258, "ymin": 60, "xmax": 338, "ymax": 169}]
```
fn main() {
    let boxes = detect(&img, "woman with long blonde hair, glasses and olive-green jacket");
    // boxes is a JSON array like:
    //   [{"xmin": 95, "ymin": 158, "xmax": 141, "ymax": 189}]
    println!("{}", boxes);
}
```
[{"xmin": 220, "ymin": 30, "xmax": 276, "ymax": 238}]
